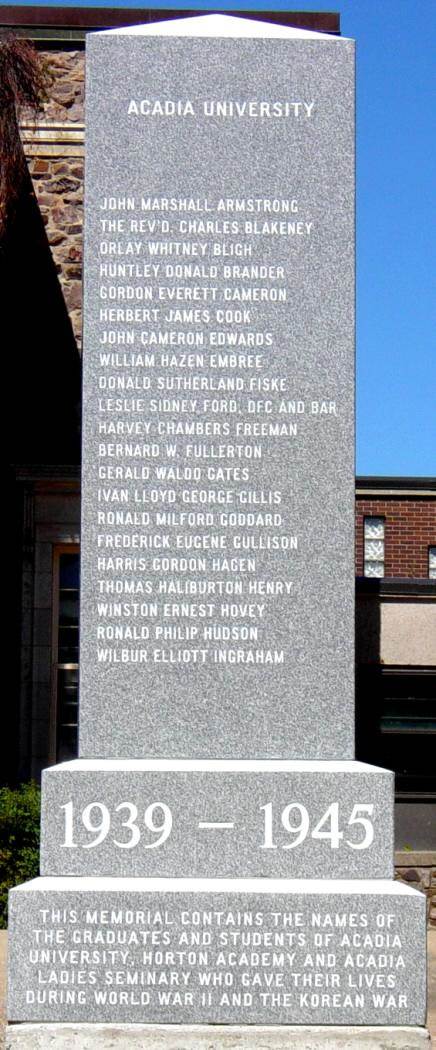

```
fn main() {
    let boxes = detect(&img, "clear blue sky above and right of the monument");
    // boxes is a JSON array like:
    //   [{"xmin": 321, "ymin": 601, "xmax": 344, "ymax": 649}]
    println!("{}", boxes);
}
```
[{"xmin": 9, "ymin": 0, "xmax": 436, "ymax": 475}]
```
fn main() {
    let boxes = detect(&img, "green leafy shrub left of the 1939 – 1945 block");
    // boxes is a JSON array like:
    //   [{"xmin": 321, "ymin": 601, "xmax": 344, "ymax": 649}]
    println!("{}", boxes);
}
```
[{"xmin": 0, "ymin": 782, "xmax": 41, "ymax": 929}]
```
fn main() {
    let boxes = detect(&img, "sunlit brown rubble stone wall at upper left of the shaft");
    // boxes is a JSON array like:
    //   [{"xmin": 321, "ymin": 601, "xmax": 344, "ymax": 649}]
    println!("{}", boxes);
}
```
[{"xmin": 22, "ymin": 50, "xmax": 85, "ymax": 349}]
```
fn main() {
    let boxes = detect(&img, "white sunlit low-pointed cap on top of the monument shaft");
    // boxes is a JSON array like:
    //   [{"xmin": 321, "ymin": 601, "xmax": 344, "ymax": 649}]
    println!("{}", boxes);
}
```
[{"xmin": 92, "ymin": 15, "xmax": 345, "ymax": 41}]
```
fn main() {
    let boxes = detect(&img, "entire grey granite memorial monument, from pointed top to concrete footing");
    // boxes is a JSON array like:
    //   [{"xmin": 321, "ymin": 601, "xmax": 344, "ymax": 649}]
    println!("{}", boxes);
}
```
[{"xmin": 6, "ymin": 10, "xmax": 429, "ymax": 1050}]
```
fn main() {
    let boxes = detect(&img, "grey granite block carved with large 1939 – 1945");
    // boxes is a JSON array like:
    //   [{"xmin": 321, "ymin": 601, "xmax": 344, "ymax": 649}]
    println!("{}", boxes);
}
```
[{"xmin": 41, "ymin": 759, "xmax": 394, "ymax": 879}]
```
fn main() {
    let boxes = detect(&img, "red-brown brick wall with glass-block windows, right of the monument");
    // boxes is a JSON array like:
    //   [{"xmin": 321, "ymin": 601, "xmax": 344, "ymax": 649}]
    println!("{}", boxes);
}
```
[{"xmin": 356, "ymin": 494, "xmax": 436, "ymax": 580}]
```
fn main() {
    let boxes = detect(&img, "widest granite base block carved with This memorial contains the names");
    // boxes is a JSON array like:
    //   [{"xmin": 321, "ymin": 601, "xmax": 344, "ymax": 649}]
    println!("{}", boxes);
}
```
[{"xmin": 8, "ymin": 878, "xmax": 427, "ymax": 1031}]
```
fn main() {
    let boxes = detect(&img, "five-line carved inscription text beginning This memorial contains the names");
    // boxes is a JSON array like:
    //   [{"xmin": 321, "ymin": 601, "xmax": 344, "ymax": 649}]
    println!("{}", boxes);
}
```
[{"xmin": 11, "ymin": 894, "xmax": 418, "ymax": 1024}]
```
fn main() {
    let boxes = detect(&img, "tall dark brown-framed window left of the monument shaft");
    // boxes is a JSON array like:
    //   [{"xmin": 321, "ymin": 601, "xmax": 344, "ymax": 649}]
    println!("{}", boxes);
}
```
[{"xmin": 53, "ymin": 545, "xmax": 79, "ymax": 762}]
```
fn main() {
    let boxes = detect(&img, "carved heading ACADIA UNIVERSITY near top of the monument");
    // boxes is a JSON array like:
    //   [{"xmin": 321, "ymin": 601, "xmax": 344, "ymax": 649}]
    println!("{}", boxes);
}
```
[{"xmin": 127, "ymin": 99, "xmax": 315, "ymax": 120}]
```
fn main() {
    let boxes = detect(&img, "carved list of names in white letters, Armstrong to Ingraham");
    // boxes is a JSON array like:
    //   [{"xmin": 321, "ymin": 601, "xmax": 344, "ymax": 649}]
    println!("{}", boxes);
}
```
[{"xmin": 94, "ymin": 191, "xmax": 340, "ymax": 670}]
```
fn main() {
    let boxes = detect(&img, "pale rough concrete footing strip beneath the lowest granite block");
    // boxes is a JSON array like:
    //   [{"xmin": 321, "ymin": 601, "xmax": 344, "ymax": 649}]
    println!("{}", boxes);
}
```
[{"xmin": 6, "ymin": 1024, "xmax": 431, "ymax": 1050}]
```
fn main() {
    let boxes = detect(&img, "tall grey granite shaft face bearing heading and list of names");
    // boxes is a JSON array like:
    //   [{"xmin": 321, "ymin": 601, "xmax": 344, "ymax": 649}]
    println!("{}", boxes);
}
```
[{"xmin": 80, "ymin": 24, "xmax": 354, "ymax": 759}]
